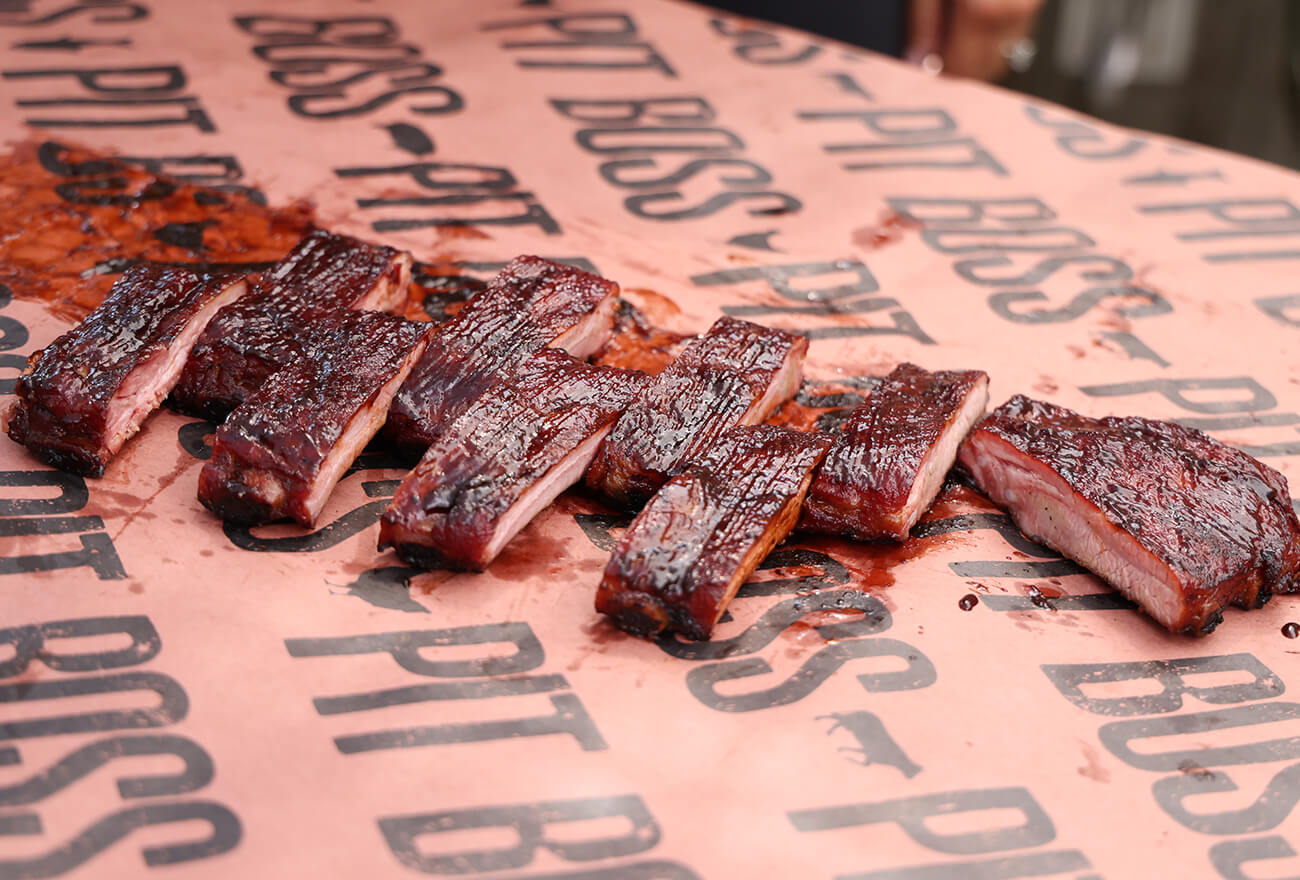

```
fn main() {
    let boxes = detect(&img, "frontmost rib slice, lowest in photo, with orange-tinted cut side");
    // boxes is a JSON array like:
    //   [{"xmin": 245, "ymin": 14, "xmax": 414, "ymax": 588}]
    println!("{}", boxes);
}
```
[{"xmin": 595, "ymin": 425, "xmax": 831, "ymax": 640}]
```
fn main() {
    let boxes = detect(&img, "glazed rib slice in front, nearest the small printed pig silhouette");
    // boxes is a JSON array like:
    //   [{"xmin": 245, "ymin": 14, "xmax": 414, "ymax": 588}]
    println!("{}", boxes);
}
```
[{"xmin": 380, "ymin": 348, "xmax": 646, "ymax": 571}]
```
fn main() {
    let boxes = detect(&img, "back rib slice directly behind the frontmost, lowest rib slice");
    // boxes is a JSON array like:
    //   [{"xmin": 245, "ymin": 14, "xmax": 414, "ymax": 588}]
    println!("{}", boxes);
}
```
[{"xmin": 586, "ymin": 317, "xmax": 809, "ymax": 507}]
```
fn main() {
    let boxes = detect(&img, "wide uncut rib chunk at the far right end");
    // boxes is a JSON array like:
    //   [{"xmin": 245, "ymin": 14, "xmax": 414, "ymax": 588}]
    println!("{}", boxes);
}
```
[{"xmin": 961, "ymin": 395, "xmax": 1300, "ymax": 633}]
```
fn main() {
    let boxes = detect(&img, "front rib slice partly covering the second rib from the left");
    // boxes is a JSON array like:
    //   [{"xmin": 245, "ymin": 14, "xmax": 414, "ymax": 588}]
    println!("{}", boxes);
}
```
[{"xmin": 199, "ymin": 311, "xmax": 432, "ymax": 528}]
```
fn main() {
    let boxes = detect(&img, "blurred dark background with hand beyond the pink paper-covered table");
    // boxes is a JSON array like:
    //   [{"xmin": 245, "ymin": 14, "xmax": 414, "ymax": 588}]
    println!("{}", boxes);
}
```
[{"xmin": 709, "ymin": 0, "xmax": 1300, "ymax": 170}]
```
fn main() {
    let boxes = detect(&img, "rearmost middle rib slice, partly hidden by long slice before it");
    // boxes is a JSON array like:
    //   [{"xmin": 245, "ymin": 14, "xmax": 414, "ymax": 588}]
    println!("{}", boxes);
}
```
[{"xmin": 384, "ymin": 256, "xmax": 619, "ymax": 456}]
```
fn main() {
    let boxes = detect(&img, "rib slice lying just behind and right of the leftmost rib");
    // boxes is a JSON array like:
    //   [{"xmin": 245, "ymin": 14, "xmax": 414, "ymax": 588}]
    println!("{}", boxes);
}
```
[{"xmin": 172, "ymin": 230, "xmax": 411, "ymax": 422}]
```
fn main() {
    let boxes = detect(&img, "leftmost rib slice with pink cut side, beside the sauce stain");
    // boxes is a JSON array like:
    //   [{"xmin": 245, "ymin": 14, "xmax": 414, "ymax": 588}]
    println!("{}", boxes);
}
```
[{"xmin": 5, "ymin": 264, "xmax": 247, "ymax": 477}]
